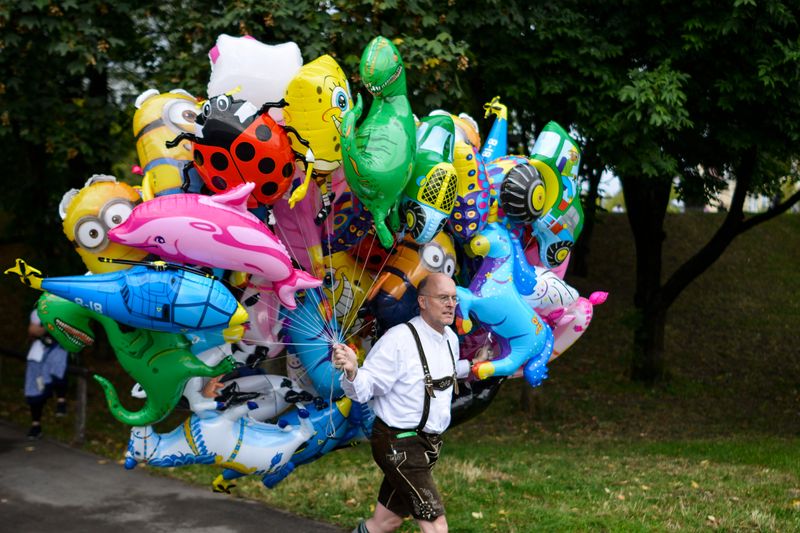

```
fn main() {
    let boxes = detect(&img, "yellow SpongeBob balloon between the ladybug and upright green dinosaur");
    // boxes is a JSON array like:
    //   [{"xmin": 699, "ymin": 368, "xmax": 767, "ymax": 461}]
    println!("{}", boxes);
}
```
[{"xmin": 283, "ymin": 55, "xmax": 353, "ymax": 222}]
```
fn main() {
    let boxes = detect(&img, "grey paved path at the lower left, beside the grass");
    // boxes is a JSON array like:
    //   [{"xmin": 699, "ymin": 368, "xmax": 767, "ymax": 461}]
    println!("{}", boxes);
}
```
[{"xmin": 0, "ymin": 421, "xmax": 342, "ymax": 533}]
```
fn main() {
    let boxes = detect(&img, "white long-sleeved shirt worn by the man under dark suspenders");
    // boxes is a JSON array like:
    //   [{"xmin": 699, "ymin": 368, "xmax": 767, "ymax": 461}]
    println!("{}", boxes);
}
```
[{"xmin": 341, "ymin": 316, "xmax": 470, "ymax": 433}]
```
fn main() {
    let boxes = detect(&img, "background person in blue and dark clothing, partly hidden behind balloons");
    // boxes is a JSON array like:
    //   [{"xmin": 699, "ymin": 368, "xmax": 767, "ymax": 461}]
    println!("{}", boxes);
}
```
[{"xmin": 25, "ymin": 309, "xmax": 68, "ymax": 440}]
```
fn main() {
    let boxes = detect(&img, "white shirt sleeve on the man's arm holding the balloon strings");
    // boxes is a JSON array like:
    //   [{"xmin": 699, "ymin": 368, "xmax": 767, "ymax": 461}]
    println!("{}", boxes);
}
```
[{"xmin": 339, "ymin": 334, "xmax": 401, "ymax": 403}]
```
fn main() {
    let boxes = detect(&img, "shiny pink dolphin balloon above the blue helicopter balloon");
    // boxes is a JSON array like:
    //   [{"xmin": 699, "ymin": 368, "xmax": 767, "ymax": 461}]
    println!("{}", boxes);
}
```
[{"xmin": 108, "ymin": 183, "xmax": 322, "ymax": 309}]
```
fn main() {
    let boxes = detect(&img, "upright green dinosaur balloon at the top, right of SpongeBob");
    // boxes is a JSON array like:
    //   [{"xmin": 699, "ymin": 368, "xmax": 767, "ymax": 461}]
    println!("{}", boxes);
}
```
[{"xmin": 341, "ymin": 37, "xmax": 417, "ymax": 248}]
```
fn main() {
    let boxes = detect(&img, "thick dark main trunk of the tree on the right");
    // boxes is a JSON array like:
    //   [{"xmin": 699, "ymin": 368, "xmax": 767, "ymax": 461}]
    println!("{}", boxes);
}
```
[{"xmin": 620, "ymin": 176, "xmax": 672, "ymax": 384}]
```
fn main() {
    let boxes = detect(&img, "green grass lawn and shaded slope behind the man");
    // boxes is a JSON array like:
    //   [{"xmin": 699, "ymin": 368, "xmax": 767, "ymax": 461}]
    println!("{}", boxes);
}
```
[{"xmin": 0, "ymin": 214, "xmax": 800, "ymax": 532}]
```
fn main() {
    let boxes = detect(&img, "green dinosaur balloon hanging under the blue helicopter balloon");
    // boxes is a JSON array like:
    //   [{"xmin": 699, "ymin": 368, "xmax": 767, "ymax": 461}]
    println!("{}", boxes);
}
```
[{"xmin": 37, "ymin": 293, "xmax": 234, "ymax": 426}]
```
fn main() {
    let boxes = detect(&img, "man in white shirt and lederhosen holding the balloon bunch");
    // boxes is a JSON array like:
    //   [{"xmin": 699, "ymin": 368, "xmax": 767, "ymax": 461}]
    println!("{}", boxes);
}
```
[{"xmin": 333, "ymin": 273, "xmax": 469, "ymax": 533}]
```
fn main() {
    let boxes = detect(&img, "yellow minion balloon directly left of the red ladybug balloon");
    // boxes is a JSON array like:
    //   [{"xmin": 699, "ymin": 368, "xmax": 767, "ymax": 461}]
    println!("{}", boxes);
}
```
[{"xmin": 133, "ymin": 89, "xmax": 197, "ymax": 200}]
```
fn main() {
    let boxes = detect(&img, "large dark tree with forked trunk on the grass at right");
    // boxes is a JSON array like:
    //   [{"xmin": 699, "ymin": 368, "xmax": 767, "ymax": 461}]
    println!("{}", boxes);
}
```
[{"xmin": 506, "ymin": 0, "xmax": 800, "ymax": 382}]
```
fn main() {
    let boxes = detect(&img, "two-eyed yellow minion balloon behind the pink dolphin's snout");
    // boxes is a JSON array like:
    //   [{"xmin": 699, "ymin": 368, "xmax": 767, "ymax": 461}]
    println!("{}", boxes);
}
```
[{"xmin": 58, "ymin": 174, "xmax": 147, "ymax": 274}]
